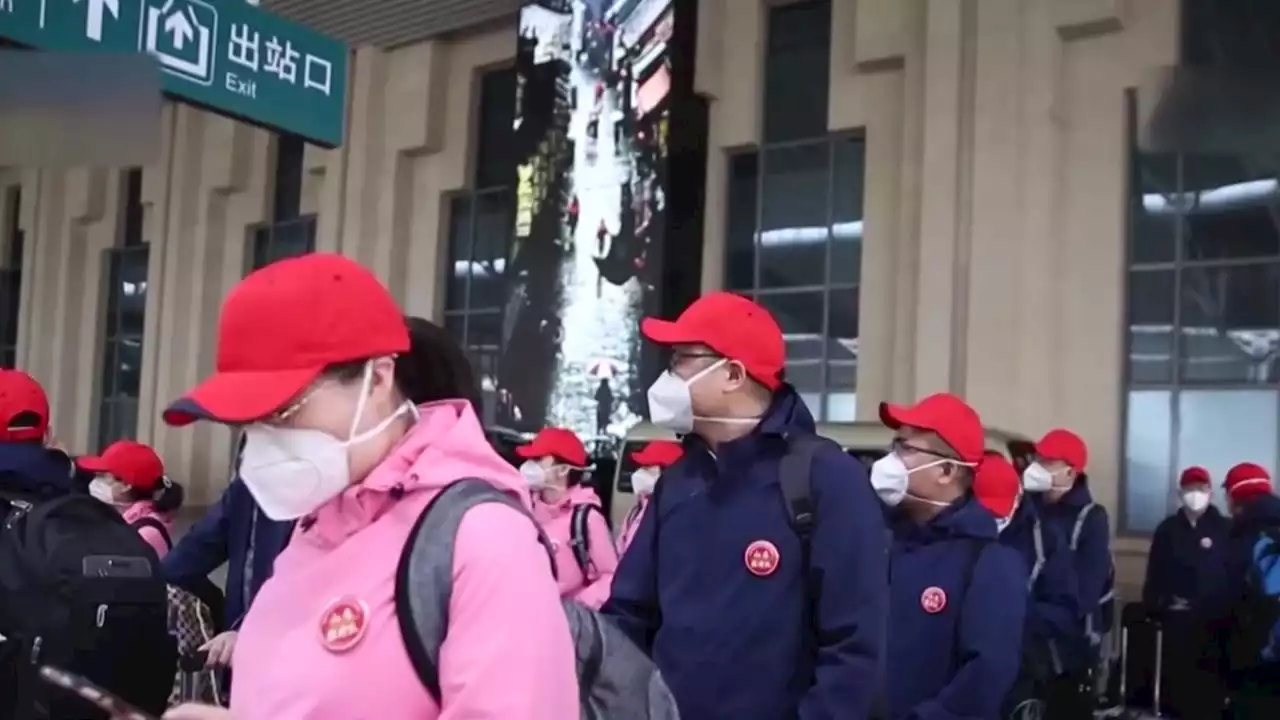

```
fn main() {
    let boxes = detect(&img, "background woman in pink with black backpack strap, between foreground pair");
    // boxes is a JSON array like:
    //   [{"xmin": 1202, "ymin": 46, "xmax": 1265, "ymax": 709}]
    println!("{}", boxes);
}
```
[{"xmin": 516, "ymin": 428, "xmax": 618, "ymax": 610}]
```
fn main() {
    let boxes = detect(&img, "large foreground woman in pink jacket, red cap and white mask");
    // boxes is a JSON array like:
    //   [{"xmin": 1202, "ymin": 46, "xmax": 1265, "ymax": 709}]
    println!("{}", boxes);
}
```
[{"xmin": 164, "ymin": 254, "xmax": 580, "ymax": 720}]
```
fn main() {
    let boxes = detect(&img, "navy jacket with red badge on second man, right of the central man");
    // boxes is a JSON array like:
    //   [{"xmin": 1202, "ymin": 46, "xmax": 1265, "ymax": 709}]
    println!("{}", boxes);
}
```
[{"xmin": 885, "ymin": 497, "xmax": 1029, "ymax": 720}]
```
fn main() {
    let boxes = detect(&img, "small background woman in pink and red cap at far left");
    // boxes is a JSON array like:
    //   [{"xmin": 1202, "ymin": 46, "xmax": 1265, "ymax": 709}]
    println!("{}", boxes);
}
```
[{"xmin": 76, "ymin": 439, "xmax": 183, "ymax": 557}]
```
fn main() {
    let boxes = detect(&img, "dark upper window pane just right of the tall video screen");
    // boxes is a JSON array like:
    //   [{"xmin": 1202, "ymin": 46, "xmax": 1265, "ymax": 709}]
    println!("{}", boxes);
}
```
[{"xmin": 764, "ymin": 0, "xmax": 831, "ymax": 142}]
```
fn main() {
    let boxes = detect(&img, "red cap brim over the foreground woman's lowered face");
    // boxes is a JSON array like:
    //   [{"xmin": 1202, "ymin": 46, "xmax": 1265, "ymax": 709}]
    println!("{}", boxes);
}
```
[{"xmin": 164, "ymin": 366, "xmax": 324, "ymax": 427}]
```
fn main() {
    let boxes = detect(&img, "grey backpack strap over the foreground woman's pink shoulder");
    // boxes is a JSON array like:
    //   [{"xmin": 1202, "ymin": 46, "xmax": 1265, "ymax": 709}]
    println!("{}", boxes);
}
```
[{"xmin": 396, "ymin": 478, "xmax": 556, "ymax": 702}]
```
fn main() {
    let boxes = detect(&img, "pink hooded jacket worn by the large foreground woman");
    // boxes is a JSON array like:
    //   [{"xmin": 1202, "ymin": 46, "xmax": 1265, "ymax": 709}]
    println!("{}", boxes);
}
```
[{"xmin": 232, "ymin": 401, "xmax": 580, "ymax": 720}]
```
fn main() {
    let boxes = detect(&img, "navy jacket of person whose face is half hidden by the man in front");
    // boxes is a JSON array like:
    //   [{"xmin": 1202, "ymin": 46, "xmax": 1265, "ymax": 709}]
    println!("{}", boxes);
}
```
[{"xmin": 1000, "ymin": 502, "xmax": 1084, "ymax": 653}]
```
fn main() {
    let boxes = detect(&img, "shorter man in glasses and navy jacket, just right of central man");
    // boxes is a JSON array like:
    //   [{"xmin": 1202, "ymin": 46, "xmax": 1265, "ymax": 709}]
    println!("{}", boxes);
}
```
[{"xmin": 872, "ymin": 393, "xmax": 1028, "ymax": 720}]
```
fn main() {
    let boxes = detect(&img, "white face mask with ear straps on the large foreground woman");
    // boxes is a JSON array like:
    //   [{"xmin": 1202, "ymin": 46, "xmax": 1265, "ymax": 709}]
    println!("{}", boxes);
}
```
[{"xmin": 241, "ymin": 361, "xmax": 416, "ymax": 520}]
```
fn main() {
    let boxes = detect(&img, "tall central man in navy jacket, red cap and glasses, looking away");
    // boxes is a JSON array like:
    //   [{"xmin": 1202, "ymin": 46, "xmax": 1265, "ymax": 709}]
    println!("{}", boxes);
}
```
[{"xmin": 603, "ymin": 292, "xmax": 888, "ymax": 720}]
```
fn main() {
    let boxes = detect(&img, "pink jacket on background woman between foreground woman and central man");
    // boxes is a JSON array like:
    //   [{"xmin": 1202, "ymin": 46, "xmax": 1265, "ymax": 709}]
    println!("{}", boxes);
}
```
[{"xmin": 524, "ymin": 486, "xmax": 618, "ymax": 610}]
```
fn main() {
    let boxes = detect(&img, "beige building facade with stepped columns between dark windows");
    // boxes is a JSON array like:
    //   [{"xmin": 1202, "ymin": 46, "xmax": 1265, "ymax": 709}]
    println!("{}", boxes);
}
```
[{"xmin": 0, "ymin": 0, "xmax": 1179, "ymax": 580}]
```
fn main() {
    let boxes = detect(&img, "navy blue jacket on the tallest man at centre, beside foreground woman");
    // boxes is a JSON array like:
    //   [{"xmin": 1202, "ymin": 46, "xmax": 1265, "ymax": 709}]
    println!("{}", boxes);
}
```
[{"xmin": 604, "ymin": 386, "xmax": 888, "ymax": 720}]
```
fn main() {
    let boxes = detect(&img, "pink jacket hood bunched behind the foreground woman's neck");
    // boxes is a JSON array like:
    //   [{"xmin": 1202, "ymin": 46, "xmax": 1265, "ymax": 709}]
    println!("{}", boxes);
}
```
[{"xmin": 308, "ymin": 400, "xmax": 530, "ymax": 542}]
